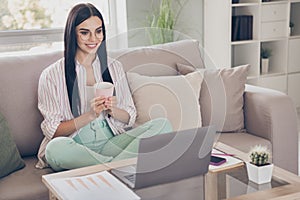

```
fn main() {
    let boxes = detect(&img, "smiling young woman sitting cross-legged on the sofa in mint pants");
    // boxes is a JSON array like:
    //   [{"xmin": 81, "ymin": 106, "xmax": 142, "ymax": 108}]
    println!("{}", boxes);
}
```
[{"xmin": 37, "ymin": 3, "xmax": 172, "ymax": 171}]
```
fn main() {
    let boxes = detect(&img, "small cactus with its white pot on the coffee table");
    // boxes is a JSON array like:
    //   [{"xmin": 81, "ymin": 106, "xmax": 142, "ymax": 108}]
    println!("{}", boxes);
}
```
[{"xmin": 246, "ymin": 145, "xmax": 274, "ymax": 184}]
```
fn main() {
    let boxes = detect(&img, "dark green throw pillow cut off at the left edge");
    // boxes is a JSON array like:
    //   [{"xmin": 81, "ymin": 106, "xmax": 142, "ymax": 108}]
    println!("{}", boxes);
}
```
[{"xmin": 0, "ymin": 113, "xmax": 25, "ymax": 178}]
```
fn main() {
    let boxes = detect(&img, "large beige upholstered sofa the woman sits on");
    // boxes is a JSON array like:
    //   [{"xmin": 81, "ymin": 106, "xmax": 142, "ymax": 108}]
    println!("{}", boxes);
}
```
[{"xmin": 0, "ymin": 40, "xmax": 298, "ymax": 200}]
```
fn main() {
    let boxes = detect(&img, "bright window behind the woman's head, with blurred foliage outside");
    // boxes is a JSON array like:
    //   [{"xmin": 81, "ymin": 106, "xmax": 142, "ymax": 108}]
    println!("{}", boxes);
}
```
[{"xmin": 0, "ymin": 0, "xmax": 115, "ymax": 53}]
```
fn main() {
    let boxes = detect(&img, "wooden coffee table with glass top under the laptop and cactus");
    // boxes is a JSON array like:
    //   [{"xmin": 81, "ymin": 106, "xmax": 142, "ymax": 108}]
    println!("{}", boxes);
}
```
[{"xmin": 42, "ymin": 143, "xmax": 300, "ymax": 200}]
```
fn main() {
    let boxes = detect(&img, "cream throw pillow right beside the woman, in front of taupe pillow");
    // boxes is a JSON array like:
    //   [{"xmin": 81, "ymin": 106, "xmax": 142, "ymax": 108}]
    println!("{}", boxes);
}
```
[{"xmin": 127, "ymin": 72, "xmax": 203, "ymax": 130}]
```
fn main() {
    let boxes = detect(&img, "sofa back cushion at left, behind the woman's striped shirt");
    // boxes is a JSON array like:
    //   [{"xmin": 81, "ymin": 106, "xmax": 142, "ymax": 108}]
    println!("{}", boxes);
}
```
[{"xmin": 0, "ymin": 52, "xmax": 62, "ymax": 156}]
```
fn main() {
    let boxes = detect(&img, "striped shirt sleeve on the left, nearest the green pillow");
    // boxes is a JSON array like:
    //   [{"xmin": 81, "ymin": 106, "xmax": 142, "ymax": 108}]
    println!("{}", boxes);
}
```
[{"xmin": 38, "ymin": 65, "xmax": 63, "ymax": 140}]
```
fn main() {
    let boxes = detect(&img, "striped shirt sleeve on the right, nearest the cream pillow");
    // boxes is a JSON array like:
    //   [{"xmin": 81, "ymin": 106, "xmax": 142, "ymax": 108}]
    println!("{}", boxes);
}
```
[{"xmin": 109, "ymin": 60, "xmax": 136, "ymax": 134}]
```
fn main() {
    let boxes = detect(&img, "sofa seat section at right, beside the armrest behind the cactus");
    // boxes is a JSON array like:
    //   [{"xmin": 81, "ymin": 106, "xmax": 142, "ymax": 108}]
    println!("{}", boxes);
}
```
[{"xmin": 218, "ymin": 133, "xmax": 272, "ymax": 160}]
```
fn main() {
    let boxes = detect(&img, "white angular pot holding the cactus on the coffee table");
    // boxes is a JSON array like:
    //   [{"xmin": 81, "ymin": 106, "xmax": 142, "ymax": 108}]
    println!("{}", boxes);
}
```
[{"xmin": 246, "ymin": 162, "xmax": 274, "ymax": 184}]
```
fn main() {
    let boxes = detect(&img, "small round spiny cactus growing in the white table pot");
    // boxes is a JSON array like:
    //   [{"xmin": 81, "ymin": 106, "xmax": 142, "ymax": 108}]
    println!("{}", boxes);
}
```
[{"xmin": 249, "ymin": 145, "xmax": 271, "ymax": 166}]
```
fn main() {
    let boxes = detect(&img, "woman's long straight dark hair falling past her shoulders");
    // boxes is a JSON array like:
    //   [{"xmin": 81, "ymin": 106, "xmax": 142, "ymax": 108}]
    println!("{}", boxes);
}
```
[{"xmin": 64, "ymin": 3, "xmax": 112, "ymax": 117}]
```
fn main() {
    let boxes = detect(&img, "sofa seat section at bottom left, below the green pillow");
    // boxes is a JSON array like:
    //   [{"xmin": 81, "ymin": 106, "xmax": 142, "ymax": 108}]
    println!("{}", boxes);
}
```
[{"xmin": 0, "ymin": 157, "xmax": 53, "ymax": 200}]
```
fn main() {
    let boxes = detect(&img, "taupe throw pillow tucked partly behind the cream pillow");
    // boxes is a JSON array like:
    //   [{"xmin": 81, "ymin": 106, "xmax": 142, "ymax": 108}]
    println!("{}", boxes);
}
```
[{"xmin": 177, "ymin": 64, "xmax": 250, "ymax": 132}]
